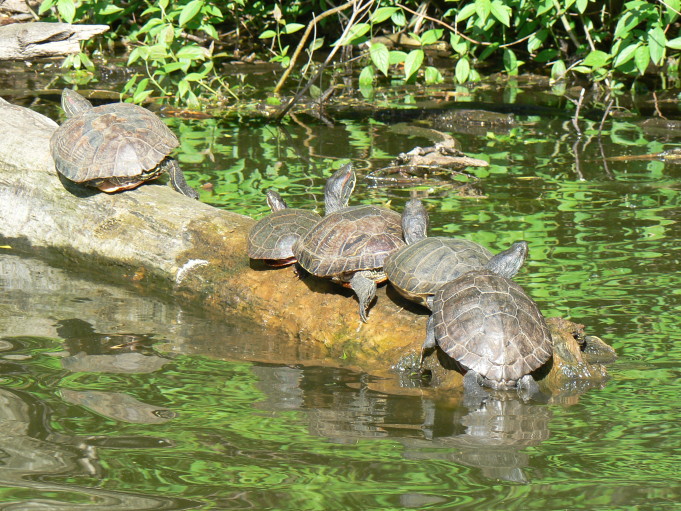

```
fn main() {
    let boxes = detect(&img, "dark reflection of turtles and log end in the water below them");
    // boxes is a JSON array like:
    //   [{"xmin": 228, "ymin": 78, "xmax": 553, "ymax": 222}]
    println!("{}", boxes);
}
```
[{"xmin": 253, "ymin": 366, "xmax": 552, "ymax": 483}]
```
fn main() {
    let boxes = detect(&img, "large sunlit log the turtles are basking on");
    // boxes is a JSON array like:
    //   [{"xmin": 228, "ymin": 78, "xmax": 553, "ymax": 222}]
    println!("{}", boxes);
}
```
[{"xmin": 0, "ymin": 98, "xmax": 605, "ymax": 394}]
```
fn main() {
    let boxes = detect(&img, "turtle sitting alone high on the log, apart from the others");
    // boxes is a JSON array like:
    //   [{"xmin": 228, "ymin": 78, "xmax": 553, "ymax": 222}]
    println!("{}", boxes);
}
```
[{"xmin": 50, "ymin": 89, "xmax": 199, "ymax": 199}]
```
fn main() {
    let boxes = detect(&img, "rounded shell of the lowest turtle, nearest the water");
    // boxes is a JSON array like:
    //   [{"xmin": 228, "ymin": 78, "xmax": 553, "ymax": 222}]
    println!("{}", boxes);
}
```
[{"xmin": 433, "ymin": 270, "xmax": 552, "ymax": 388}]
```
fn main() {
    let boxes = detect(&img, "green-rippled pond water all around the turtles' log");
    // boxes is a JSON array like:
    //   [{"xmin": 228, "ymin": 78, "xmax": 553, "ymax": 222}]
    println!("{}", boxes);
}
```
[{"xmin": 0, "ymin": 86, "xmax": 681, "ymax": 510}]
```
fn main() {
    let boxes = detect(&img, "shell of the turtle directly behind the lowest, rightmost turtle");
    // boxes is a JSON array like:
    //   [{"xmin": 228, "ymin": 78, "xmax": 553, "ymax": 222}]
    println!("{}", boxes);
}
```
[{"xmin": 384, "ymin": 237, "xmax": 492, "ymax": 303}]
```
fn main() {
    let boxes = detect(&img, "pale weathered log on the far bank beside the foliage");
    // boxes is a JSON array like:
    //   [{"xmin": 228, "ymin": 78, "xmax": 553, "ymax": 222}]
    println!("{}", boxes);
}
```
[{"xmin": 0, "ymin": 22, "xmax": 109, "ymax": 60}]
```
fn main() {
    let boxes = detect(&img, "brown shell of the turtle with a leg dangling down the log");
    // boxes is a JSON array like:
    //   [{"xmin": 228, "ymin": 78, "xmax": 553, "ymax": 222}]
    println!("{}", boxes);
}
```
[{"xmin": 293, "ymin": 206, "xmax": 405, "ymax": 277}]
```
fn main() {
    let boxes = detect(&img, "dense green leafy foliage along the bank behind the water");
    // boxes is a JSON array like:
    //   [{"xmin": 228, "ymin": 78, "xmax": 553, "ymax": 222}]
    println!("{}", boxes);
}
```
[{"xmin": 35, "ymin": 0, "xmax": 681, "ymax": 105}]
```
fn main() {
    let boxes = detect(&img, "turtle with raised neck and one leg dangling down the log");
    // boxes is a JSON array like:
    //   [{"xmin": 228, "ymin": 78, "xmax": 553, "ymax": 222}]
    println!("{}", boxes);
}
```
[{"xmin": 293, "ymin": 165, "xmax": 405, "ymax": 322}]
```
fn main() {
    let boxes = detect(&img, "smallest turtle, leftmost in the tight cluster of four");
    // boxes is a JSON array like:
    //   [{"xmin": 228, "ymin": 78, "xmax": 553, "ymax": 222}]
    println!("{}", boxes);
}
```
[{"xmin": 248, "ymin": 190, "xmax": 322, "ymax": 266}]
